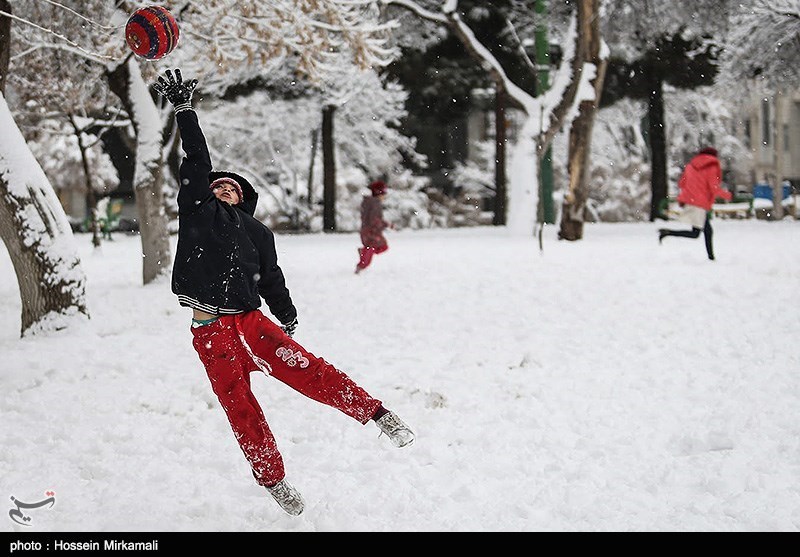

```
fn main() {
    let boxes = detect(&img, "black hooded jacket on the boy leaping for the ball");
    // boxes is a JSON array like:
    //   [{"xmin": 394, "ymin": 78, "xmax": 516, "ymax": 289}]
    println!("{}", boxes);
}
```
[{"xmin": 172, "ymin": 110, "xmax": 297, "ymax": 324}]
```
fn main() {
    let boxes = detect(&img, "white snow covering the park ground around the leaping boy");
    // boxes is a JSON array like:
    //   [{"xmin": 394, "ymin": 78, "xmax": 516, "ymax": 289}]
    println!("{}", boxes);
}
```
[{"xmin": 0, "ymin": 219, "xmax": 800, "ymax": 534}]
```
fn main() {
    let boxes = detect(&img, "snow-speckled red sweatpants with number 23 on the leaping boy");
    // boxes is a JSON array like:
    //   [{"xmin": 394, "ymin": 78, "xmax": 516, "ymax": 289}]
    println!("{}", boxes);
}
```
[{"xmin": 192, "ymin": 310, "xmax": 381, "ymax": 486}]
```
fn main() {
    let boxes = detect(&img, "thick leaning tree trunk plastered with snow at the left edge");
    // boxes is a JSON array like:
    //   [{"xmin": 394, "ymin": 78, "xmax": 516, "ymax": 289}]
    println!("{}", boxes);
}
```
[{"xmin": 0, "ymin": 94, "xmax": 89, "ymax": 336}]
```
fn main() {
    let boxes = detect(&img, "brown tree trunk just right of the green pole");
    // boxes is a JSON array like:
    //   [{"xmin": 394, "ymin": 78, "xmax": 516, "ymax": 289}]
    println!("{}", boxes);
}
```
[{"xmin": 558, "ymin": 0, "xmax": 606, "ymax": 241}]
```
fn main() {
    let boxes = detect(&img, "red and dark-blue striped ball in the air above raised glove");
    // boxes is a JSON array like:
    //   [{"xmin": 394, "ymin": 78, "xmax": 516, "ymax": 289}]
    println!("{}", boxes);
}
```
[{"xmin": 125, "ymin": 6, "xmax": 180, "ymax": 60}]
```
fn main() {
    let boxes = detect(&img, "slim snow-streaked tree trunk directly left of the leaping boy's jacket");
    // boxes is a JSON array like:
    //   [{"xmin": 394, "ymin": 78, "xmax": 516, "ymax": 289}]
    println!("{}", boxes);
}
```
[{"xmin": 106, "ymin": 57, "xmax": 172, "ymax": 284}]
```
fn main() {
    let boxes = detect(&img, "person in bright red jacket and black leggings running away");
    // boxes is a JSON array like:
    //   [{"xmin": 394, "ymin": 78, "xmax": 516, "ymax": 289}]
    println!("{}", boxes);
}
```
[{"xmin": 658, "ymin": 147, "xmax": 733, "ymax": 261}]
